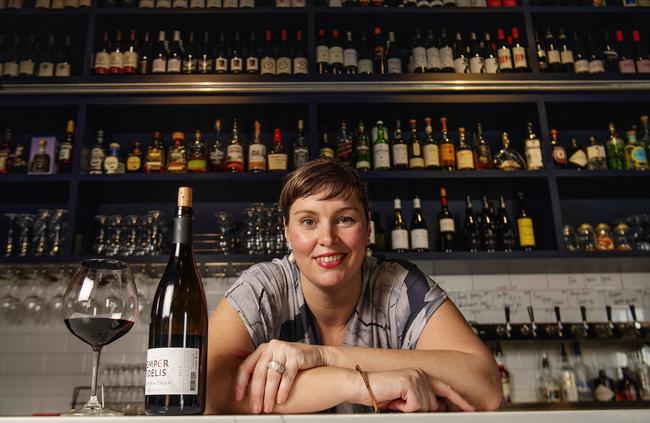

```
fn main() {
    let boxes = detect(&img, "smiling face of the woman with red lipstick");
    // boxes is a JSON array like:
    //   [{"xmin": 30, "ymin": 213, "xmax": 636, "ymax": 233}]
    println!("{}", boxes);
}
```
[{"xmin": 285, "ymin": 194, "xmax": 370, "ymax": 289}]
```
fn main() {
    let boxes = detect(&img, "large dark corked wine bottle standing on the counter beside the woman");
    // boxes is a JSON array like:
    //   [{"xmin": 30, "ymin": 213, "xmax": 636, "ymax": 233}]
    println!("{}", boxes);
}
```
[{"xmin": 145, "ymin": 187, "xmax": 208, "ymax": 415}]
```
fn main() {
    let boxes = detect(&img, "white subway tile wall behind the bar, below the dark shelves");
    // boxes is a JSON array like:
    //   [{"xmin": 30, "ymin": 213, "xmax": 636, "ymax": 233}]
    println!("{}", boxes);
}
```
[{"xmin": 0, "ymin": 269, "xmax": 650, "ymax": 416}]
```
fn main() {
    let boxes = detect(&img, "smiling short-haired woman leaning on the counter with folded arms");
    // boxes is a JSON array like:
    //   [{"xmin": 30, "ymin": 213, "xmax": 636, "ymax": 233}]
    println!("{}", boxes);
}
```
[{"xmin": 206, "ymin": 160, "xmax": 501, "ymax": 414}]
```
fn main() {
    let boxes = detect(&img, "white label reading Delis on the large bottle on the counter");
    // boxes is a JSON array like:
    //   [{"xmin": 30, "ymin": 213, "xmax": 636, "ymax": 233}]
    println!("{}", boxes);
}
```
[{"xmin": 144, "ymin": 348, "xmax": 201, "ymax": 395}]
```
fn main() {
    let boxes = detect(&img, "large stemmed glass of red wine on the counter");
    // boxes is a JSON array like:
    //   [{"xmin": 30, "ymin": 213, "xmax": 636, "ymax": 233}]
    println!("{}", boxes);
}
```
[{"xmin": 63, "ymin": 259, "xmax": 138, "ymax": 416}]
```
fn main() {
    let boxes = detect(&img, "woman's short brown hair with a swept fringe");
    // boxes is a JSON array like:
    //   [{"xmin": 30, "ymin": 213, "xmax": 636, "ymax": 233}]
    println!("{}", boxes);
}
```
[{"xmin": 280, "ymin": 159, "xmax": 370, "ymax": 222}]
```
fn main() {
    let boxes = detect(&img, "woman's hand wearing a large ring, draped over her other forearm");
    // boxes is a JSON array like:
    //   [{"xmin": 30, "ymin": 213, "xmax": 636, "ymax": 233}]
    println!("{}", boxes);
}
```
[{"xmin": 235, "ymin": 339, "xmax": 326, "ymax": 413}]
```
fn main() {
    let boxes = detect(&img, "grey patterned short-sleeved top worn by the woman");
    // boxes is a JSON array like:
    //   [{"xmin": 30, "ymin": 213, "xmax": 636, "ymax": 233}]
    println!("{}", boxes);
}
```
[{"xmin": 226, "ymin": 257, "xmax": 447, "ymax": 413}]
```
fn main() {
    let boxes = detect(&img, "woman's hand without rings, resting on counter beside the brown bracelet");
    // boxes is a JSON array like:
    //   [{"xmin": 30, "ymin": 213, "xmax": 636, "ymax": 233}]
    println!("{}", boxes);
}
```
[{"xmin": 358, "ymin": 369, "xmax": 475, "ymax": 413}]
